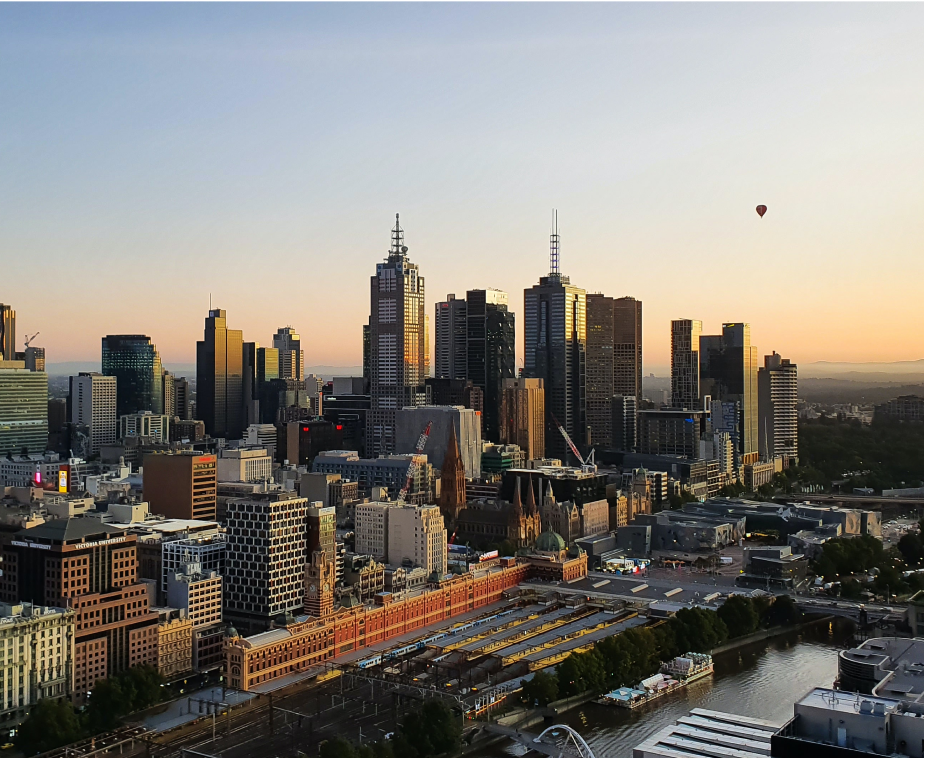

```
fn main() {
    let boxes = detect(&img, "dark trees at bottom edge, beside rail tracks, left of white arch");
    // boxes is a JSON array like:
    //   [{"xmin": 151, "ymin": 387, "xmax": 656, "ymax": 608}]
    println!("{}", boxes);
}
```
[{"xmin": 319, "ymin": 700, "xmax": 462, "ymax": 758}]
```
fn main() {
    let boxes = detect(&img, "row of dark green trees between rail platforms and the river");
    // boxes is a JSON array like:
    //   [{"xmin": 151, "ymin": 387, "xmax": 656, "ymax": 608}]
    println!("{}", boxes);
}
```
[{"xmin": 523, "ymin": 595, "xmax": 801, "ymax": 705}]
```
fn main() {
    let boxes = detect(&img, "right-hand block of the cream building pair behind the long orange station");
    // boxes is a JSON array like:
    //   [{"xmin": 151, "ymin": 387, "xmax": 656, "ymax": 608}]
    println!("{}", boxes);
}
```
[{"xmin": 388, "ymin": 505, "xmax": 446, "ymax": 577}]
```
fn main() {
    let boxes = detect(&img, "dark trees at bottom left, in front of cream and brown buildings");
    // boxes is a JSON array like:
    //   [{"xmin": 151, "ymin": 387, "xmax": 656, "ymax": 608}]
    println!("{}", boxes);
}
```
[{"xmin": 16, "ymin": 666, "xmax": 164, "ymax": 755}]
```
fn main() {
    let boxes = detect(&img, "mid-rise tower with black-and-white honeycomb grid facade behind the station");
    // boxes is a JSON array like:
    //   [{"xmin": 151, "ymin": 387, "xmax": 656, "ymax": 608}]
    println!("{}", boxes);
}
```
[{"xmin": 223, "ymin": 492, "xmax": 308, "ymax": 630}]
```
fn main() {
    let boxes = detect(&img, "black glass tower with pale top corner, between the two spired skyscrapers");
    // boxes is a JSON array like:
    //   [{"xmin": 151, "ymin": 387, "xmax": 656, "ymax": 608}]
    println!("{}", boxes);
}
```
[{"xmin": 466, "ymin": 289, "xmax": 516, "ymax": 440}]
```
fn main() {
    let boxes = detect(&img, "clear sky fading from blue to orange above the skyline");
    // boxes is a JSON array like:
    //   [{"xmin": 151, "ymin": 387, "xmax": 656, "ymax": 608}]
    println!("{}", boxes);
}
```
[{"xmin": 0, "ymin": 3, "xmax": 925, "ymax": 373}]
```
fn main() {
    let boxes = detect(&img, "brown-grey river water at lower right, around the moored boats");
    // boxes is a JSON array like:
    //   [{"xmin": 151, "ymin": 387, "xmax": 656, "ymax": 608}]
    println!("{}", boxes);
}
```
[{"xmin": 483, "ymin": 622, "xmax": 852, "ymax": 758}]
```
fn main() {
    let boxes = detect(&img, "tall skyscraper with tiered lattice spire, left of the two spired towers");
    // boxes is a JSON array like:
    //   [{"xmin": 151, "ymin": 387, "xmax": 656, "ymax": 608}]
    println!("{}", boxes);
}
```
[{"xmin": 366, "ymin": 214, "xmax": 427, "ymax": 455}]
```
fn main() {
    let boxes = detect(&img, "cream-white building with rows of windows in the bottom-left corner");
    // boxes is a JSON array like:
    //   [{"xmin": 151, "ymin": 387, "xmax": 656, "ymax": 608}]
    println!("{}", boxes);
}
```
[{"xmin": 0, "ymin": 603, "xmax": 74, "ymax": 728}]
